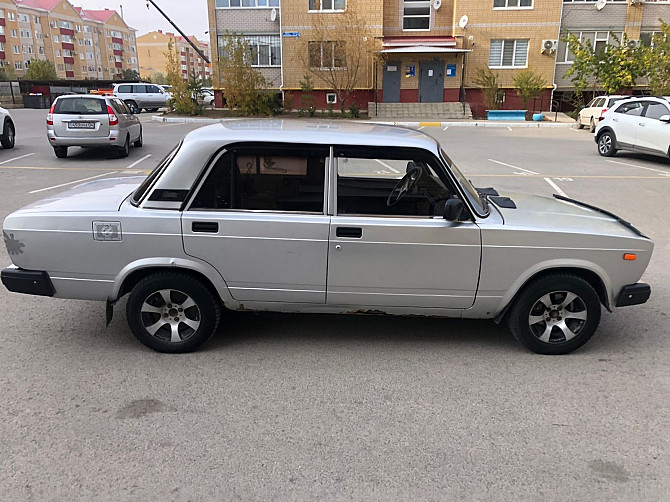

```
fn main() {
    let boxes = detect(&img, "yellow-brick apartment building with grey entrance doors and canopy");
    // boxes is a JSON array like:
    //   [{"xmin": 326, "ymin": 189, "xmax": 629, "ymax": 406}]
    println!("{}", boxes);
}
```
[{"xmin": 208, "ymin": 0, "xmax": 670, "ymax": 115}]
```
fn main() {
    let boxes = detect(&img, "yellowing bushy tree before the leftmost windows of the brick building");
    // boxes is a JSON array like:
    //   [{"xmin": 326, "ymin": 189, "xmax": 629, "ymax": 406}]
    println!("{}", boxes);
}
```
[{"xmin": 219, "ymin": 33, "xmax": 275, "ymax": 115}]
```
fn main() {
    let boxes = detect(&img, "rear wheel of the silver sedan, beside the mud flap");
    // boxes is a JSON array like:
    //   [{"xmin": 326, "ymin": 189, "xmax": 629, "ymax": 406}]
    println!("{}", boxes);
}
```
[{"xmin": 126, "ymin": 272, "xmax": 221, "ymax": 353}]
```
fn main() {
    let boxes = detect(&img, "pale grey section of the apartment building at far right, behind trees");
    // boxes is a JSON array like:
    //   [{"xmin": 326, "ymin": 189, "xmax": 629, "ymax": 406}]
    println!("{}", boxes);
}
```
[{"xmin": 554, "ymin": 0, "xmax": 670, "ymax": 102}]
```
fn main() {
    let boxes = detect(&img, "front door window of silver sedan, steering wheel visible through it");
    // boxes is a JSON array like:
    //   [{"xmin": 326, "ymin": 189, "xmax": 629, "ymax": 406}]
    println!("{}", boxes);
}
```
[{"xmin": 335, "ymin": 147, "xmax": 454, "ymax": 218}]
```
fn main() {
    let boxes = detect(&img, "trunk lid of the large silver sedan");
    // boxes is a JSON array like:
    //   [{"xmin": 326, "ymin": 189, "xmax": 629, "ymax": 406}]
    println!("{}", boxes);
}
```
[{"xmin": 18, "ymin": 176, "xmax": 146, "ymax": 213}]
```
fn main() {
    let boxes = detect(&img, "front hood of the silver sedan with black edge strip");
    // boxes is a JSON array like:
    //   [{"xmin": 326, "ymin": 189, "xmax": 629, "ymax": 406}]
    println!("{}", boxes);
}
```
[{"xmin": 489, "ymin": 192, "xmax": 644, "ymax": 237}]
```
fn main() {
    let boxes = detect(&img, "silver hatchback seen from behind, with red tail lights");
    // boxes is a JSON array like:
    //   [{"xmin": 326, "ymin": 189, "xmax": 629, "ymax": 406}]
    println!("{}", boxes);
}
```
[{"xmin": 47, "ymin": 94, "xmax": 143, "ymax": 159}]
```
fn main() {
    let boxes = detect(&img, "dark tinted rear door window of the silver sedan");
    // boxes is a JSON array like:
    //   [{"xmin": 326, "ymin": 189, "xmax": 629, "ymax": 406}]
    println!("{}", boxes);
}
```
[{"xmin": 191, "ymin": 147, "xmax": 328, "ymax": 213}]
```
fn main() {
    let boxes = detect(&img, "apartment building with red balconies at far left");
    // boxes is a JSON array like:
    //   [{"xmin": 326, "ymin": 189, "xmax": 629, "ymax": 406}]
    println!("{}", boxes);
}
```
[{"xmin": 0, "ymin": 0, "xmax": 139, "ymax": 80}]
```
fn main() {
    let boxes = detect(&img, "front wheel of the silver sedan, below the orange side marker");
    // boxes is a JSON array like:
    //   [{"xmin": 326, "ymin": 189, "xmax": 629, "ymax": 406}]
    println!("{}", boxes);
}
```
[{"xmin": 507, "ymin": 274, "xmax": 600, "ymax": 355}]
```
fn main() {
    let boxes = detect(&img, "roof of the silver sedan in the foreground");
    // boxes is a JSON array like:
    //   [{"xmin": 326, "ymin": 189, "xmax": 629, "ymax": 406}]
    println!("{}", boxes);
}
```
[{"xmin": 184, "ymin": 119, "xmax": 444, "ymax": 152}]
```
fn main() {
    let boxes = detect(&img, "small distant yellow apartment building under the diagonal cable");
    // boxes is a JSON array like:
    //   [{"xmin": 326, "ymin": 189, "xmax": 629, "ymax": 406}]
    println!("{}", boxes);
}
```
[{"xmin": 137, "ymin": 30, "xmax": 212, "ymax": 80}]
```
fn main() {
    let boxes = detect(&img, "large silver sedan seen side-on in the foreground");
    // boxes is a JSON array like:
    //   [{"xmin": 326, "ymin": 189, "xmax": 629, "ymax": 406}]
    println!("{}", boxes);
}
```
[{"xmin": 2, "ymin": 120, "xmax": 654, "ymax": 354}]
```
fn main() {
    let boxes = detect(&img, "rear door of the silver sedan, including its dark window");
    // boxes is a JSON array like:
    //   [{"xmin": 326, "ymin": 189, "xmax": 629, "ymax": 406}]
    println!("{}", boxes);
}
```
[{"xmin": 182, "ymin": 143, "xmax": 330, "ymax": 304}]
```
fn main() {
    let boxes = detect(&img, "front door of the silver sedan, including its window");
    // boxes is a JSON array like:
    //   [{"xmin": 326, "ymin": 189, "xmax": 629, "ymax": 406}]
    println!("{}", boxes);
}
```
[{"xmin": 327, "ymin": 147, "xmax": 481, "ymax": 310}]
